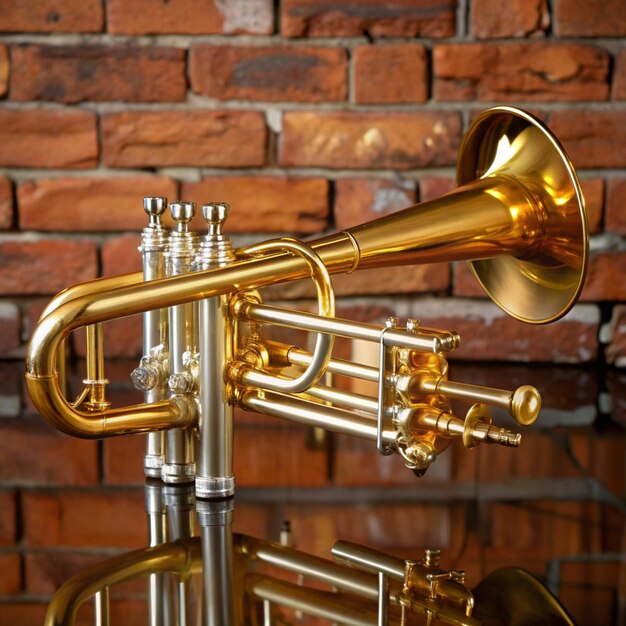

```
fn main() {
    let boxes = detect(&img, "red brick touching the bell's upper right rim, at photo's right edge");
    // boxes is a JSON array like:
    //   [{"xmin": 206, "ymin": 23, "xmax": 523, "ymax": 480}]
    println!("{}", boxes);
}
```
[{"xmin": 549, "ymin": 110, "xmax": 626, "ymax": 168}]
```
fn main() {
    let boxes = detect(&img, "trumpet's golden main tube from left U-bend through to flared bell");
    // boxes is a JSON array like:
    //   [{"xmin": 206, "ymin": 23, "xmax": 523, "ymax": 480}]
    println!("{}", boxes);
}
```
[{"xmin": 26, "ymin": 107, "xmax": 588, "ymax": 437}]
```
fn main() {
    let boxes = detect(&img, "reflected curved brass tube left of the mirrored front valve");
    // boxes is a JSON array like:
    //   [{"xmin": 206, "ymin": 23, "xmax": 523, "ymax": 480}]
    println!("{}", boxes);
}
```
[{"xmin": 45, "ymin": 539, "xmax": 202, "ymax": 626}]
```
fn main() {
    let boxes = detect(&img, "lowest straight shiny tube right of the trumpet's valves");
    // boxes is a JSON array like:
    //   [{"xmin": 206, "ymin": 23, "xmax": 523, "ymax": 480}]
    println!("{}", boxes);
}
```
[{"xmin": 239, "ymin": 389, "xmax": 397, "ymax": 447}]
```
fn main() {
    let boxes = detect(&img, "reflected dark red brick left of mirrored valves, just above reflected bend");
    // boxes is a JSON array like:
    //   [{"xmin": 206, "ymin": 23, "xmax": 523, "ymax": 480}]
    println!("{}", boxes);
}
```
[{"xmin": 23, "ymin": 490, "xmax": 147, "ymax": 547}]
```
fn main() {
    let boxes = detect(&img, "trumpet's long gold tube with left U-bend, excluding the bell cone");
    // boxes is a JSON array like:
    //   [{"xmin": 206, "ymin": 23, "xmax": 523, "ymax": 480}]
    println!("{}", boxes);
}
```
[{"xmin": 26, "ymin": 236, "xmax": 353, "ymax": 438}]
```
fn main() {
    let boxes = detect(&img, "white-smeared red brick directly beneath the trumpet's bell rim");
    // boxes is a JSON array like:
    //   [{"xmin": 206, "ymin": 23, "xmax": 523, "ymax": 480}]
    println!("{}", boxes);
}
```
[{"xmin": 414, "ymin": 298, "xmax": 600, "ymax": 363}]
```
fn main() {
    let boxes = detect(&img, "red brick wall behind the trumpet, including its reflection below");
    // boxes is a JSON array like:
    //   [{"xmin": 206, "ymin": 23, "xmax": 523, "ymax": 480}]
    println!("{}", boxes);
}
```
[{"xmin": 0, "ymin": 0, "xmax": 626, "ymax": 624}]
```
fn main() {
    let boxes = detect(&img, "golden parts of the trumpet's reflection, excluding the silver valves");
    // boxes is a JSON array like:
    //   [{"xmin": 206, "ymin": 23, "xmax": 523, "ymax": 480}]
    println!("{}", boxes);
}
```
[{"xmin": 45, "ymin": 534, "xmax": 573, "ymax": 626}]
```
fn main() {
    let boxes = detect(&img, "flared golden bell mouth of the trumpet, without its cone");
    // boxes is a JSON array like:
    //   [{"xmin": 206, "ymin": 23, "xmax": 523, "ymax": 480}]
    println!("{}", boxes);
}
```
[{"xmin": 457, "ymin": 106, "xmax": 588, "ymax": 324}]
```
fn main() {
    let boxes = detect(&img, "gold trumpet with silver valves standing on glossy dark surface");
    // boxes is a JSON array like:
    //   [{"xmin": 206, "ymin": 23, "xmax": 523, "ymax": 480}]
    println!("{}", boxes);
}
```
[{"xmin": 26, "ymin": 106, "xmax": 588, "ymax": 625}]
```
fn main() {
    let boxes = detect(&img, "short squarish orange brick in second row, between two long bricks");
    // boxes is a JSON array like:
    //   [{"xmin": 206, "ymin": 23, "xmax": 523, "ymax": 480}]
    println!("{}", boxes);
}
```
[{"xmin": 352, "ymin": 44, "xmax": 429, "ymax": 104}]
